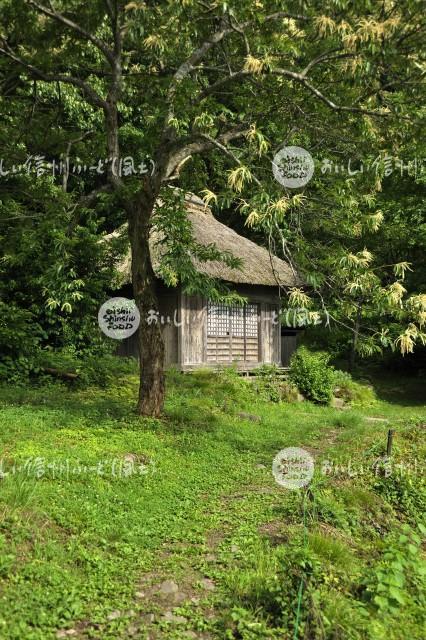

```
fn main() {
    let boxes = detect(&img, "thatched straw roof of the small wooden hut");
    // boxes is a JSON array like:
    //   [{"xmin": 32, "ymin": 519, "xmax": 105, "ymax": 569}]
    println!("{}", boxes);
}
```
[{"xmin": 110, "ymin": 194, "xmax": 302, "ymax": 287}]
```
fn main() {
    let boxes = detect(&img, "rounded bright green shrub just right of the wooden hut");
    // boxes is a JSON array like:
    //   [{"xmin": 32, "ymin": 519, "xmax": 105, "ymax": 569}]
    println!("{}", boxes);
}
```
[{"xmin": 289, "ymin": 347, "xmax": 335, "ymax": 404}]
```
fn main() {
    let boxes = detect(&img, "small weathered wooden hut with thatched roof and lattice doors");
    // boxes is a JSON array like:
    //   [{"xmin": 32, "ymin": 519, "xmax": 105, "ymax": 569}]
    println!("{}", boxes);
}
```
[{"xmin": 109, "ymin": 194, "xmax": 302, "ymax": 371}]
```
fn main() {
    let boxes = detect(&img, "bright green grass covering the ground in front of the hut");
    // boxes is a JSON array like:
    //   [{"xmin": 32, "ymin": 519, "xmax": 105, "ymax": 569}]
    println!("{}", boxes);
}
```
[{"xmin": 0, "ymin": 371, "xmax": 426, "ymax": 640}]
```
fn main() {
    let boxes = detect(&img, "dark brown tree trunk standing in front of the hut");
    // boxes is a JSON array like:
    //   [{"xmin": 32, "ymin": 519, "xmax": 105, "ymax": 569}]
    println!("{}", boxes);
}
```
[{"xmin": 129, "ymin": 180, "xmax": 165, "ymax": 417}]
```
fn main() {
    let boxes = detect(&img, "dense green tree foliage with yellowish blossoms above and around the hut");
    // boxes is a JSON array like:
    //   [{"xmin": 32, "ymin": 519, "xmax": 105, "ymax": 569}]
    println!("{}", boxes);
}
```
[{"xmin": 0, "ymin": 0, "xmax": 425, "ymax": 404}]
